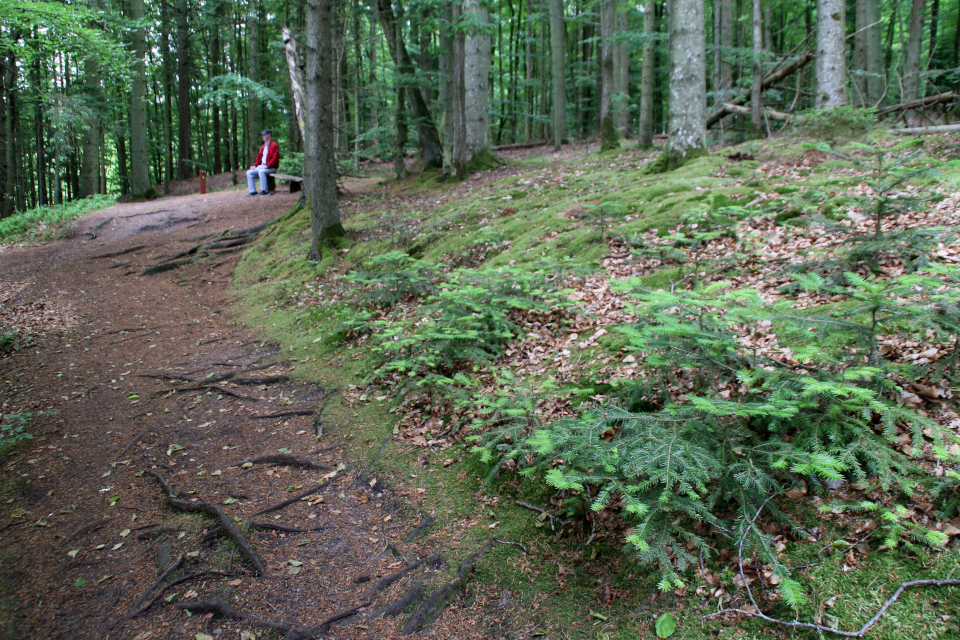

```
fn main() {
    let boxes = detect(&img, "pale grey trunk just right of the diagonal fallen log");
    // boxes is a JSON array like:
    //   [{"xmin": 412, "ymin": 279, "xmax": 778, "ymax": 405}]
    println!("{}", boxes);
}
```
[{"xmin": 816, "ymin": 0, "xmax": 844, "ymax": 109}]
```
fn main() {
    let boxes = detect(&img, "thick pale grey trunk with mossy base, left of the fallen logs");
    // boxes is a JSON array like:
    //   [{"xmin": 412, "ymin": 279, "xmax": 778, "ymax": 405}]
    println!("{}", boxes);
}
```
[{"xmin": 663, "ymin": 0, "xmax": 707, "ymax": 169}]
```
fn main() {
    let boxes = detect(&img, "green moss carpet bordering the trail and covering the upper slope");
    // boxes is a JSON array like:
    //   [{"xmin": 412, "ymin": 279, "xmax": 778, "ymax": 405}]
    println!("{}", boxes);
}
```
[{"xmin": 235, "ymin": 132, "xmax": 960, "ymax": 640}]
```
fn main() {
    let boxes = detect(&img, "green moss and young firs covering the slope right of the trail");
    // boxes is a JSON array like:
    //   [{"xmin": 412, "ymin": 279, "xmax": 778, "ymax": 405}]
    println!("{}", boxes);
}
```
[{"xmin": 235, "ymin": 142, "xmax": 960, "ymax": 639}]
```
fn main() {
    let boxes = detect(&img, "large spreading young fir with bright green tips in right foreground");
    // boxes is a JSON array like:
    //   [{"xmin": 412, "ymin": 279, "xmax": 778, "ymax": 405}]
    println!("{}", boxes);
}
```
[{"xmin": 524, "ymin": 267, "xmax": 960, "ymax": 604}]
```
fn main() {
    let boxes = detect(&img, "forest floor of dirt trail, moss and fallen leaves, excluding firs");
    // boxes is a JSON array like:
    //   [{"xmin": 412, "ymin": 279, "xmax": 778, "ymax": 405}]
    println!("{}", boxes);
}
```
[{"xmin": 0, "ymin": 138, "xmax": 960, "ymax": 640}]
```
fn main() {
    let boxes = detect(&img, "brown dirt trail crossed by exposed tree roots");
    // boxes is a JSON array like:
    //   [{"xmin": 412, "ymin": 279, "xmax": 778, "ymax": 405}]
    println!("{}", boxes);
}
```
[{"xmin": 0, "ymin": 191, "xmax": 472, "ymax": 640}]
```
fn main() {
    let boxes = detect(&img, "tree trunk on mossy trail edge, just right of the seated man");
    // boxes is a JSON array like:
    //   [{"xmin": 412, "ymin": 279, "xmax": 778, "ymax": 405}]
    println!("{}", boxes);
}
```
[{"xmin": 304, "ymin": 0, "xmax": 343, "ymax": 261}]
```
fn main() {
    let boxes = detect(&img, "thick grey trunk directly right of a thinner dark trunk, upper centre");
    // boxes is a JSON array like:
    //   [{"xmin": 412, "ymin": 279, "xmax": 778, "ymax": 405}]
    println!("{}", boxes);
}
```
[{"xmin": 464, "ymin": 0, "xmax": 491, "ymax": 162}]
